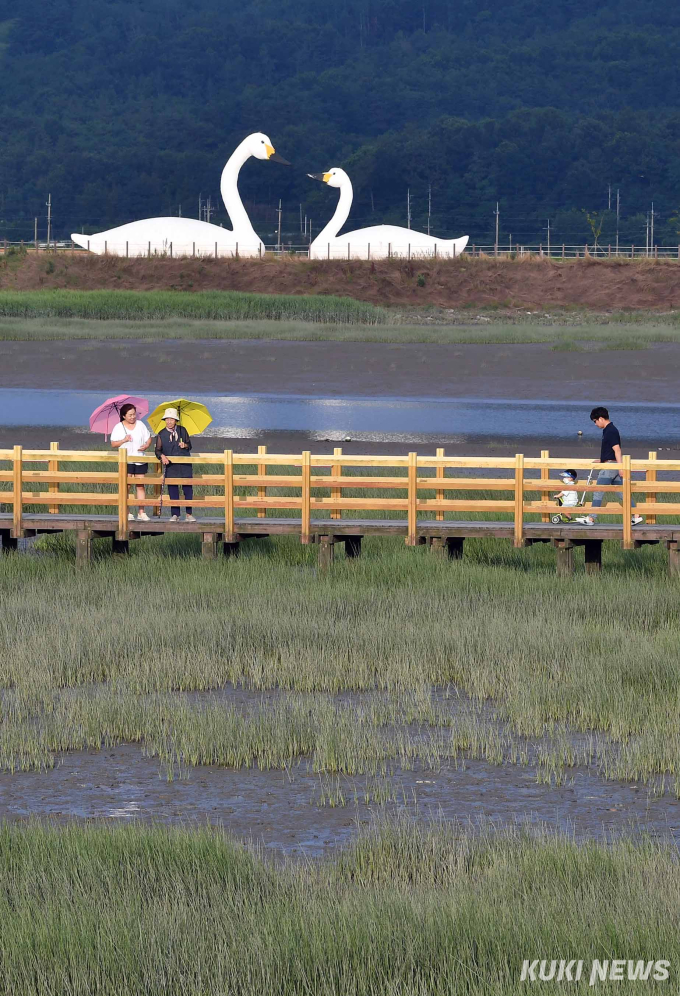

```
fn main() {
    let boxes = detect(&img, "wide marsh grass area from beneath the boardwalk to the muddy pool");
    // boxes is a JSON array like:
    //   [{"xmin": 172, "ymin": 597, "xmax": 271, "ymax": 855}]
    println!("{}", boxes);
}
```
[{"xmin": 0, "ymin": 536, "xmax": 680, "ymax": 792}]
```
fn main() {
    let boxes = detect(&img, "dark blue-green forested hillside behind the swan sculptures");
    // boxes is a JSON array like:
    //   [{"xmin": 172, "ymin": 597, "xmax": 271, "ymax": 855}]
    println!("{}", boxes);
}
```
[{"xmin": 0, "ymin": 0, "xmax": 680, "ymax": 244}]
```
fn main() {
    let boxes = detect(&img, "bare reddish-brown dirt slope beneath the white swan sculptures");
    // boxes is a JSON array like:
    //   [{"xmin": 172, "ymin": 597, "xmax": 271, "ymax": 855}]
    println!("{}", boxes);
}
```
[{"xmin": 0, "ymin": 252, "xmax": 680, "ymax": 311}]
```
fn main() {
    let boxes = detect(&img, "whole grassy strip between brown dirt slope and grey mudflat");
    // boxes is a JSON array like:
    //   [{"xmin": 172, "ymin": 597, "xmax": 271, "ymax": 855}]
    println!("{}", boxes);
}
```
[{"xmin": 0, "ymin": 290, "xmax": 680, "ymax": 350}]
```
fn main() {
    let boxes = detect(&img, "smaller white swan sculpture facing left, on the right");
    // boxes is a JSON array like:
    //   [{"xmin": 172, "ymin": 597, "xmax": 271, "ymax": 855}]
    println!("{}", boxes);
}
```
[{"xmin": 307, "ymin": 166, "xmax": 469, "ymax": 259}]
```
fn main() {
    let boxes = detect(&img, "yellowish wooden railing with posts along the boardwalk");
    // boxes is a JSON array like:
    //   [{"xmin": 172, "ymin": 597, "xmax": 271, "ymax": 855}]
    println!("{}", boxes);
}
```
[{"xmin": 0, "ymin": 443, "xmax": 680, "ymax": 547}]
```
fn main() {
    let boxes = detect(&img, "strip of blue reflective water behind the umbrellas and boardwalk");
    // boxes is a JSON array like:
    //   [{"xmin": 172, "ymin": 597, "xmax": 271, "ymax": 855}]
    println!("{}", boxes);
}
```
[{"xmin": 0, "ymin": 388, "xmax": 680, "ymax": 446}]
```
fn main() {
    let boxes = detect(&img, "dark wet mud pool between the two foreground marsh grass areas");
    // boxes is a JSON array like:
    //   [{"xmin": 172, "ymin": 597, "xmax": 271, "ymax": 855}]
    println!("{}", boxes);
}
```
[{"xmin": 0, "ymin": 744, "xmax": 680, "ymax": 857}]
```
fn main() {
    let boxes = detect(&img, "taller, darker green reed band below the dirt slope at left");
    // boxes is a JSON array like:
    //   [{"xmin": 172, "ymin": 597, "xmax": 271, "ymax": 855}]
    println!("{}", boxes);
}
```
[{"xmin": 0, "ymin": 290, "xmax": 387, "ymax": 325}]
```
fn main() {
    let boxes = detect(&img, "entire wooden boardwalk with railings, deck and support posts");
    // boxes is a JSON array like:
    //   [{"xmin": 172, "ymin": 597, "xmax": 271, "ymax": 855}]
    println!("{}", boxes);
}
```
[{"xmin": 0, "ymin": 443, "xmax": 680, "ymax": 575}]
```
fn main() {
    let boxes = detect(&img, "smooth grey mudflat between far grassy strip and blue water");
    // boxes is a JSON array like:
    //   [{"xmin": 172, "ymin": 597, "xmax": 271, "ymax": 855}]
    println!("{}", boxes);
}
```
[{"xmin": 0, "ymin": 339, "xmax": 680, "ymax": 400}]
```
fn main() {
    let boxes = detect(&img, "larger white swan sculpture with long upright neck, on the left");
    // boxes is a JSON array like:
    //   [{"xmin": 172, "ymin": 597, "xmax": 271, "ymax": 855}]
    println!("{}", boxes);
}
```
[{"xmin": 71, "ymin": 132, "xmax": 290, "ymax": 256}]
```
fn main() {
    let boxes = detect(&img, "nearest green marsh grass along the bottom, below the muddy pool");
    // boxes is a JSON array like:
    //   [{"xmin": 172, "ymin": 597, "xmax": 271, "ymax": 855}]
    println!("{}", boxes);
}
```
[{"xmin": 0, "ymin": 824, "xmax": 680, "ymax": 996}]
